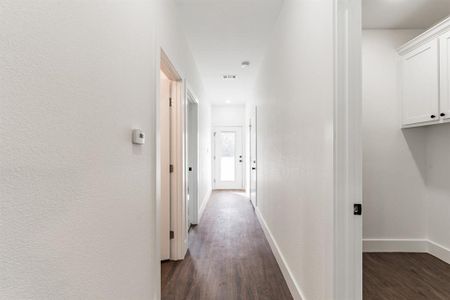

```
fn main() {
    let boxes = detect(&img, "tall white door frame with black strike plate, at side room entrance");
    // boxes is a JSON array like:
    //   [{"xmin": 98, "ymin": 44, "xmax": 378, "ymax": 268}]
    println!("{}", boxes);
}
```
[{"xmin": 333, "ymin": 0, "xmax": 362, "ymax": 300}]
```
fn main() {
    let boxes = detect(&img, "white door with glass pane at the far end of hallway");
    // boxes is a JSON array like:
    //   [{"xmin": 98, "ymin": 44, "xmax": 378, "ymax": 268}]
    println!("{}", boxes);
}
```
[{"xmin": 213, "ymin": 127, "xmax": 244, "ymax": 189}]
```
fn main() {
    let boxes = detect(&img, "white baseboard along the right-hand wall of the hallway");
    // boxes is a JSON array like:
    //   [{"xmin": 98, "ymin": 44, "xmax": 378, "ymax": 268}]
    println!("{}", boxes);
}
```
[{"xmin": 255, "ymin": 207, "xmax": 305, "ymax": 300}]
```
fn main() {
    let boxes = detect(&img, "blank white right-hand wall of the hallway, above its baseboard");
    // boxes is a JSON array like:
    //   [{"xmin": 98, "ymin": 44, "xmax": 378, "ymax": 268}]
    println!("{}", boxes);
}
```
[{"xmin": 249, "ymin": 0, "xmax": 334, "ymax": 299}]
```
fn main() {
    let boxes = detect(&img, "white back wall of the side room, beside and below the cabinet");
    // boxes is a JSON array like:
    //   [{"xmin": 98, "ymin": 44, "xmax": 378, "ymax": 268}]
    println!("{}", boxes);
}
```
[{"xmin": 362, "ymin": 30, "xmax": 426, "ymax": 239}]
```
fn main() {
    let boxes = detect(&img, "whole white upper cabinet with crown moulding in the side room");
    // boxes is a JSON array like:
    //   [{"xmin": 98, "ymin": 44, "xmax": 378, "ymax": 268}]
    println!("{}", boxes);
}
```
[{"xmin": 398, "ymin": 18, "xmax": 450, "ymax": 127}]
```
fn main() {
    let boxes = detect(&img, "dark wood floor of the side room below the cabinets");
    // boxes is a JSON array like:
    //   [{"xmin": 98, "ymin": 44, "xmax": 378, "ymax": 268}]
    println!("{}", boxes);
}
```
[{"xmin": 363, "ymin": 253, "xmax": 450, "ymax": 300}]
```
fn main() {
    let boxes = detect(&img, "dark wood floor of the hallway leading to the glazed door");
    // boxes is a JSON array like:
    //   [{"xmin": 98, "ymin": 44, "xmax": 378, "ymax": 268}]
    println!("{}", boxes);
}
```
[{"xmin": 161, "ymin": 191, "xmax": 292, "ymax": 300}]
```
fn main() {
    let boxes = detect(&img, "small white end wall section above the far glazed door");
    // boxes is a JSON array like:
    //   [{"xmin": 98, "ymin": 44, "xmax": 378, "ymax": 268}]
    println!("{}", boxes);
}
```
[{"xmin": 211, "ymin": 105, "xmax": 245, "ymax": 126}]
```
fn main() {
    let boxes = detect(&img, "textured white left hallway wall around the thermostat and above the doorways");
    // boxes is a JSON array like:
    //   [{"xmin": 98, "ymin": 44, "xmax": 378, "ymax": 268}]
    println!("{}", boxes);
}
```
[{"xmin": 0, "ymin": 0, "xmax": 211, "ymax": 299}]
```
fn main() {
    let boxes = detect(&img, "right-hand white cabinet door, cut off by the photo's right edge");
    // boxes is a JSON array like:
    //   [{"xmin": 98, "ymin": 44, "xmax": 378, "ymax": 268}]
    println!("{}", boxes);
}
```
[{"xmin": 440, "ymin": 31, "xmax": 450, "ymax": 120}]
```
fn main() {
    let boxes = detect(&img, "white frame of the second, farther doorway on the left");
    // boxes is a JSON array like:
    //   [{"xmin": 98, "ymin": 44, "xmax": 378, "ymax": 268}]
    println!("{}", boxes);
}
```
[{"xmin": 185, "ymin": 83, "xmax": 200, "ymax": 225}]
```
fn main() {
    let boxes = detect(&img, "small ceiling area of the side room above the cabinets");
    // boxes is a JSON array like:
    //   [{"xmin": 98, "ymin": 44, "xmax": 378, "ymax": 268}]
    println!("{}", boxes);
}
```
[{"xmin": 362, "ymin": 0, "xmax": 450, "ymax": 29}]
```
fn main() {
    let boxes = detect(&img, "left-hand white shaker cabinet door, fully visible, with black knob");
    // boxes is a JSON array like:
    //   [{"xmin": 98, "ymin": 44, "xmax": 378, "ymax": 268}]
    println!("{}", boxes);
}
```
[{"xmin": 401, "ymin": 39, "xmax": 439, "ymax": 125}]
